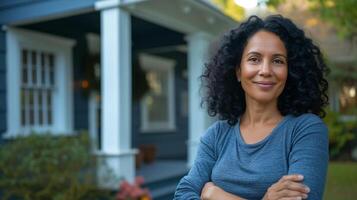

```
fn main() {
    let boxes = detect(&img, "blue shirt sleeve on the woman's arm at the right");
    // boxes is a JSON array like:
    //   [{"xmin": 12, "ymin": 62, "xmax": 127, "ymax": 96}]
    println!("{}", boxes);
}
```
[{"xmin": 289, "ymin": 115, "xmax": 329, "ymax": 200}]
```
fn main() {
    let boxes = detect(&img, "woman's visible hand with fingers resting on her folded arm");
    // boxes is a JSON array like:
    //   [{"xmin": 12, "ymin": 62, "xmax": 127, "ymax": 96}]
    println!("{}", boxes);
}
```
[{"xmin": 263, "ymin": 174, "xmax": 310, "ymax": 200}]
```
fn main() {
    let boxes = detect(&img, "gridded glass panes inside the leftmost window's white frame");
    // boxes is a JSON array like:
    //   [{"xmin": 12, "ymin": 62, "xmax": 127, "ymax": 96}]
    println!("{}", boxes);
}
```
[{"xmin": 20, "ymin": 48, "xmax": 55, "ymax": 127}]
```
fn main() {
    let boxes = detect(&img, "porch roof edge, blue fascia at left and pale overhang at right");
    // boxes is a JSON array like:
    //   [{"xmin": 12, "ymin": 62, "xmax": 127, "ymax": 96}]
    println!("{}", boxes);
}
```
[{"xmin": 0, "ymin": 0, "xmax": 238, "ymax": 36}]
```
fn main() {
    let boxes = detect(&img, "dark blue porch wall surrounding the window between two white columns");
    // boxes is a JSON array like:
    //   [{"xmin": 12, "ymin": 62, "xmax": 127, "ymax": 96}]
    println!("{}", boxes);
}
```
[{"xmin": 132, "ymin": 53, "xmax": 188, "ymax": 159}]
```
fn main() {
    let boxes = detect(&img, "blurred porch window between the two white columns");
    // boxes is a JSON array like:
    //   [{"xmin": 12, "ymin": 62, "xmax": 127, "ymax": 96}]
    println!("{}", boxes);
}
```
[{"xmin": 139, "ymin": 54, "xmax": 175, "ymax": 132}]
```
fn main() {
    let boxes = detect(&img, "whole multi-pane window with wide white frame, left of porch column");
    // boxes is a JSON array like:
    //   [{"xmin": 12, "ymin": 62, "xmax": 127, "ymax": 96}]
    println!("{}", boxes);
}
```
[{"xmin": 5, "ymin": 28, "xmax": 74, "ymax": 137}]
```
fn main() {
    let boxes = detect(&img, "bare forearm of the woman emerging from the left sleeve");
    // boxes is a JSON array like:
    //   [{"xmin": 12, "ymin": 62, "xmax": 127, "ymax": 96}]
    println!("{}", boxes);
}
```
[{"xmin": 201, "ymin": 182, "xmax": 243, "ymax": 200}]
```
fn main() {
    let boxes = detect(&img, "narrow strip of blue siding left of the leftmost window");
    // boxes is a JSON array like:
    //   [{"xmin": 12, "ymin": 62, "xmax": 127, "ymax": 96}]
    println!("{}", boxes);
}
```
[{"xmin": 0, "ymin": 30, "xmax": 7, "ymax": 139}]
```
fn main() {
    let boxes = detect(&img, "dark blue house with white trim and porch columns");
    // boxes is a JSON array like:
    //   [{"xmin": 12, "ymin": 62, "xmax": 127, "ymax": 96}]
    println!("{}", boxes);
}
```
[{"xmin": 0, "ymin": 0, "xmax": 236, "ymax": 196}]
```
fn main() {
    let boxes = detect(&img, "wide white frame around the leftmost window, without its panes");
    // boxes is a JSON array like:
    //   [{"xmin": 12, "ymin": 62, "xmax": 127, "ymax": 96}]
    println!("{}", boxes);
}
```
[{"xmin": 4, "ymin": 27, "xmax": 75, "ymax": 137}]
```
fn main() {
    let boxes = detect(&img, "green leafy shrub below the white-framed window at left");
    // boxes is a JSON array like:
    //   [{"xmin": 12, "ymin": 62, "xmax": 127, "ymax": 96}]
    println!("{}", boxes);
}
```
[{"xmin": 0, "ymin": 134, "xmax": 108, "ymax": 200}]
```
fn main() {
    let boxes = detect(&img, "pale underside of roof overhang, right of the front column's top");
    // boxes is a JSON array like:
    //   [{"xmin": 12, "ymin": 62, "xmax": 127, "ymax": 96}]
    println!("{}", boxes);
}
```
[{"xmin": 121, "ymin": 0, "xmax": 238, "ymax": 35}]
